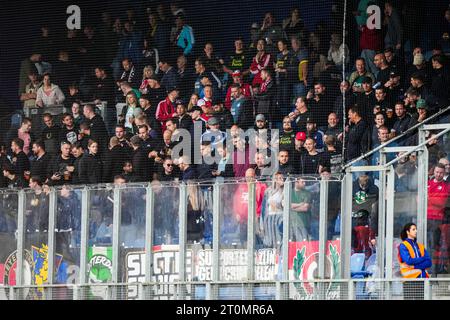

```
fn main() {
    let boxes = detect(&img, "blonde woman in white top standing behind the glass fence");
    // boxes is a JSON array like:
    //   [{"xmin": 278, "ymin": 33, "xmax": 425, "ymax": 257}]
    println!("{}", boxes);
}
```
[{"xmin": 262, "ymin": 173, "xmax": 284, "ymax": 249}]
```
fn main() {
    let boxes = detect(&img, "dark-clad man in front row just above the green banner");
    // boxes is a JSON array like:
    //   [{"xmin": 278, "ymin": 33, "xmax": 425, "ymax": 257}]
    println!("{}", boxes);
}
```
[{"xmin": 78, "ymin": 140, "xmax": 103, "ymax": 184}]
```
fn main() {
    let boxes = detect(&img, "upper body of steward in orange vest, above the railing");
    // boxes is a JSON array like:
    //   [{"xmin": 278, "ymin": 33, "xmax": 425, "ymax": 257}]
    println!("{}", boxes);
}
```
[{"xmin": 398, "ymin": 223, "xmax": 431, "ymax": 279}]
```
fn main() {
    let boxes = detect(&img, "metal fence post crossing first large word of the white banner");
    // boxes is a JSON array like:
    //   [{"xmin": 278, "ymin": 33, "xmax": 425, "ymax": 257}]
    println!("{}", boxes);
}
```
[{"xmin": 144, "ymin": 183, "xmax": 154, "ymax": 283}]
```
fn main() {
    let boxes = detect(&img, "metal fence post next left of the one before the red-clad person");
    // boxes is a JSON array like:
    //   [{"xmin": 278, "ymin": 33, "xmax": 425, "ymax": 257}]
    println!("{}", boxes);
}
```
[{"xmin": 212, "ymin": 181, "xmax": 222, "ymax": 281}]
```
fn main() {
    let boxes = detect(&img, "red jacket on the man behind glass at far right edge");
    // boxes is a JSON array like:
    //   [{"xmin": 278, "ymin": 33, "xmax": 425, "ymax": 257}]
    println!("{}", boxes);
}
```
[{"xmin": 427, "ymin": 179, "xmax": 450, "ymax": 220}]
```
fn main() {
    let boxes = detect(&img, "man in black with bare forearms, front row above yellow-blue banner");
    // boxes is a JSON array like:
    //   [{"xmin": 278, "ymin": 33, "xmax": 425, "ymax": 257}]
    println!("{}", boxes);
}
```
[{"xmin": 47, "ymin": 141, "xmax": 75, "ymax": 186}]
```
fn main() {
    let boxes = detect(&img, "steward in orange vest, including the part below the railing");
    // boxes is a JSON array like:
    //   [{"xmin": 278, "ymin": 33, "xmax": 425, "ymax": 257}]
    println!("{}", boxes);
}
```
[{"xmin": 398, "ymin": 223, "xmax": 431, "ymax": 300}]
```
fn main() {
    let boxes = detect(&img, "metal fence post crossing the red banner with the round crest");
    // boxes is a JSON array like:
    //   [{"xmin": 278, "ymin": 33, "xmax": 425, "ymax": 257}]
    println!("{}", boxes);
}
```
[{"xmin": 319, "ymin": 179, "xmax": 329, "ymax": 279}]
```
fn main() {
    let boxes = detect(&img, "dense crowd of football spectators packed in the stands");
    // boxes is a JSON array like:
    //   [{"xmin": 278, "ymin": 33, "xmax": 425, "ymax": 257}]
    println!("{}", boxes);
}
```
[{"xmin": 0, "ymin": 0, "xmax": 450, "ymax": 270}]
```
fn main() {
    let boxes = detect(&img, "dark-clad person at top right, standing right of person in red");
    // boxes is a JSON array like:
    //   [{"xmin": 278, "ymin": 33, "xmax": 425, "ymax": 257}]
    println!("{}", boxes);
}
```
[{"xmin": 384, "ymin": 1, "xmax": 403, "ymax": 52}]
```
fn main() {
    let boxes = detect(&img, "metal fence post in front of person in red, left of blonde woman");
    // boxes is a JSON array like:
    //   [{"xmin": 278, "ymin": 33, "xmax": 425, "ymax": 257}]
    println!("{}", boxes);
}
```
[{"xmin": 247, "ymin": 182, "xmax": 256, "ymax": 280}]
